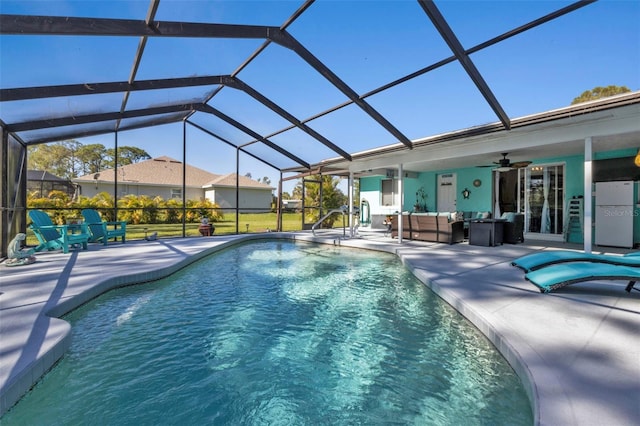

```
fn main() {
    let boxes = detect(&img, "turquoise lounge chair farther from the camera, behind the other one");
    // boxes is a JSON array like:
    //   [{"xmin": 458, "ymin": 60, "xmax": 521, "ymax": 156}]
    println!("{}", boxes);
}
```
[{"xmin": 511, "ymin": 250, "xmax": 640, "ymax": 272}]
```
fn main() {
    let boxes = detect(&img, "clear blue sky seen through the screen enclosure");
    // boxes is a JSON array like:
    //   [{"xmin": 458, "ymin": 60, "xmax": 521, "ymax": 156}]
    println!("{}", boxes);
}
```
[{"xmin": 0, "ymin": 0, "xmax": 640, "ymax": 194}]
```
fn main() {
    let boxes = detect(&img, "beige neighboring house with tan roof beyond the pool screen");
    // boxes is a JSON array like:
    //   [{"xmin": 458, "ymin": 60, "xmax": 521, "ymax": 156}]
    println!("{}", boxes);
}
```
[{"xmin": 73, "ymin": 156, "xmax": 274, "ymax": 212}]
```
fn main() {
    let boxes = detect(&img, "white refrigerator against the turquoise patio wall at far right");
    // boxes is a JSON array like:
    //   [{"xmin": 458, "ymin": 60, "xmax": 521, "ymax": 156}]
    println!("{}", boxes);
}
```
[{"xmin": 595, "ymin": 181, "xmax": 635, "ymax": 248}]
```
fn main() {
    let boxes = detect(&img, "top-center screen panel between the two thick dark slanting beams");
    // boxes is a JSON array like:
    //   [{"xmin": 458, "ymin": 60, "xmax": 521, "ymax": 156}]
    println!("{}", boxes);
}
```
[{"xmin": 289, "ymin": 1, "xmax": 451, "ymax": 94}]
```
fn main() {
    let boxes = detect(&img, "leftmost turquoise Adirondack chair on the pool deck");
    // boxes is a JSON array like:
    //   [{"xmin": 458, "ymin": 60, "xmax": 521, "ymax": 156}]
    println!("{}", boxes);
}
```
[{"xmin": 29, "ymin": 210, "xmax": 89, "ymax": 253}]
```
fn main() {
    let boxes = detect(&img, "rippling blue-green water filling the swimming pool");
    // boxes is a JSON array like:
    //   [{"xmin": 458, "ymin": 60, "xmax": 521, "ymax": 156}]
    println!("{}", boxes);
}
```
[{"xmin": 2, "ymin": 241, "xmax": 533, "ymax": 426}]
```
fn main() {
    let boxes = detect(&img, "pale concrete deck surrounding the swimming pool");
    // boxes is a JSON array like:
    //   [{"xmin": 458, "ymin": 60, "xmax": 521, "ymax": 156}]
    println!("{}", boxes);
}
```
[{"xmin": 0, "ymin": 232, "xmax": 640, "ymax": 425}]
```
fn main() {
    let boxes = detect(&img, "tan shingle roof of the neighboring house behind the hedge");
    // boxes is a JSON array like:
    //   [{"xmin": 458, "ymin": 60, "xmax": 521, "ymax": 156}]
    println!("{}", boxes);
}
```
[{"xmin": 73, "ymin": 156, "xmax": 273, "ymax": 190}]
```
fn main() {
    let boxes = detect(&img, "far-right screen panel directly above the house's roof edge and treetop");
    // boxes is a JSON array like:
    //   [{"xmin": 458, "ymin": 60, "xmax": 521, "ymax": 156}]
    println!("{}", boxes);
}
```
[{"xmin": 472, "ymin": 1, "xmax": 640, "ymax": 117}]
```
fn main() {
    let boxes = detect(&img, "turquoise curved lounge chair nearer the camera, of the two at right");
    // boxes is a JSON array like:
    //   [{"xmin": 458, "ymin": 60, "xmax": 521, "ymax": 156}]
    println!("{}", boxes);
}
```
[{"xmin": 525, "ymin": 262, "xmax": 640, "ymax": 293}]
